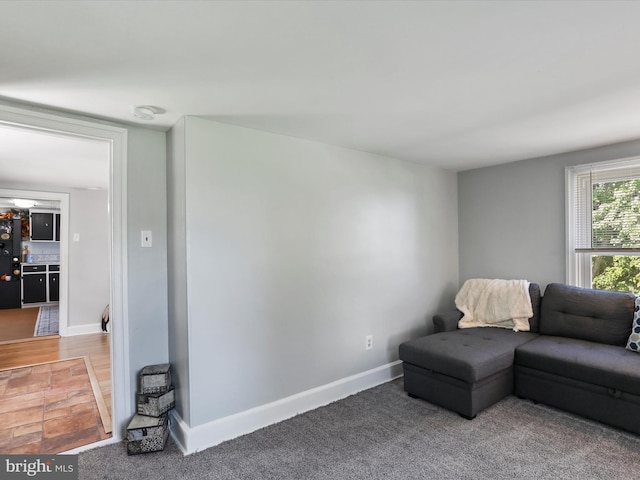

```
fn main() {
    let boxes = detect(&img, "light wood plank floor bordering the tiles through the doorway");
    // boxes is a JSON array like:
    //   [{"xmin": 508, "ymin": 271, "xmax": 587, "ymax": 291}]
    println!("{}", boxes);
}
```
[{"xmin": 0, "ymin": 333, "xmax": 111, "ymax": 450}]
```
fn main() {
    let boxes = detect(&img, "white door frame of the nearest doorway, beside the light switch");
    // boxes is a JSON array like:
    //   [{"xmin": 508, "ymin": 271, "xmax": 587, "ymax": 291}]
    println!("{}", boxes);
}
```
[{"xmin": 0, "ymin": 102, "xmax": 133, "ymax": 446}]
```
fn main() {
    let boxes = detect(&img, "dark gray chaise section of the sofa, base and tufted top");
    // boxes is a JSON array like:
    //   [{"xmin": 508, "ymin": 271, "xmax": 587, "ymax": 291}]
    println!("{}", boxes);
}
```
[{"xmin": 400, "ymin": 327, "xmax": 538, "ymax": 419}]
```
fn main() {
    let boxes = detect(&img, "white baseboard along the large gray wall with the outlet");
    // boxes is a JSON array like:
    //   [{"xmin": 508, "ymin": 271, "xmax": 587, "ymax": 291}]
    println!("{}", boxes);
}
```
[{"xmin": 170, "ymin": 360, "xmax": 402, "ymax": 455}]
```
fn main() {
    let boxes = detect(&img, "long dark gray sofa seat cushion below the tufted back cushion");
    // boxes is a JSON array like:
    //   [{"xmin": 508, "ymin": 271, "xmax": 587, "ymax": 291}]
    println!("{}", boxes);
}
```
[{"xmin": 515, "ymin": 335, "xmax": 640, "ymax": 395}]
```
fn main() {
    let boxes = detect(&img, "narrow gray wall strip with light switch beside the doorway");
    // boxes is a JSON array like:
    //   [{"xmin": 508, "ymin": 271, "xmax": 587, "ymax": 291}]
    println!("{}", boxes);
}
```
[{"xmin": 125, "ymin": 127, "xmax": 169, "ymax": 406}]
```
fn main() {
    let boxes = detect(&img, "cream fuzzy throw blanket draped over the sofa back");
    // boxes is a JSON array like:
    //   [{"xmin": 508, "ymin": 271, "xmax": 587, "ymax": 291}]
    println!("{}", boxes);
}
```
[{"xmin": 456, "ymin": 278, "xmax": 533, "ymax": 332}]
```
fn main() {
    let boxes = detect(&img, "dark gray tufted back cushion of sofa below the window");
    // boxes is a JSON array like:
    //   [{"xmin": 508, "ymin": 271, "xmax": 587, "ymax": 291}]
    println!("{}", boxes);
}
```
[{"xmin": 540, "ymin": 283, "xmax": 635, "ymax": 346}]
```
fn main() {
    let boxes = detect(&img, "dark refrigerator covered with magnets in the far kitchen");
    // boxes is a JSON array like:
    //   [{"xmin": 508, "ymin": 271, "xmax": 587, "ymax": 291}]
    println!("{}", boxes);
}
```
[{"xmin": 0, "ymin": 219, "xmax": 22, "ymax": 309}]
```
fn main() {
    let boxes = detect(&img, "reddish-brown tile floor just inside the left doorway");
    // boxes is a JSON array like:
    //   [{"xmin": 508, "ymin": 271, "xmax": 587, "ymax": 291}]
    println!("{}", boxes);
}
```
[{"xmin": 0, "ymin": 358, "xmax": 110, "ymax": 454}]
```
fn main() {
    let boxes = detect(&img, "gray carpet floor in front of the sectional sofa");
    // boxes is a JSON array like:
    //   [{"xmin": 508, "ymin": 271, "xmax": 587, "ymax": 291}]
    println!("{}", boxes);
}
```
[{"xmin": 79, "ymin": 380, "xmax": 640, "ymax": 480}]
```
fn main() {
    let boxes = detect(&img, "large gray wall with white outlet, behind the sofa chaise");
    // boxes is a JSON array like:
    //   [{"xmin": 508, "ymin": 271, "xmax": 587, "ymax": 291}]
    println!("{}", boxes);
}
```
[{"xmin": 169, "ymin": 117, "xmax": 458, "ymax": 427}]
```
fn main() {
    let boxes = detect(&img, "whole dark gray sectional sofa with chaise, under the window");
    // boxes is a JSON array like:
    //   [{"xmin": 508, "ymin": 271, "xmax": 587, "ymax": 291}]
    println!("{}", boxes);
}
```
[{"xmin": 400, "ymin": 283, "xmax": 640, "ymax": 434}]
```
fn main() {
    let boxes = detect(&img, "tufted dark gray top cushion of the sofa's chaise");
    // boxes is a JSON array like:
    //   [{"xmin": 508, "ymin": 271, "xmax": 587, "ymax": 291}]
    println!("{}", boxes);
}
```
[{"xmin": 400, "ymin": 327, "xmax": 540, "ymax": 383}]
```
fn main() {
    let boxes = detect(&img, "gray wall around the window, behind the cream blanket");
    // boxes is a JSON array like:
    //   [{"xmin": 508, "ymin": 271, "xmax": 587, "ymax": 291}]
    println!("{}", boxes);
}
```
[{"xmin": 458, "ymin": 137, "xmax": 640, "ymax": 288}]
